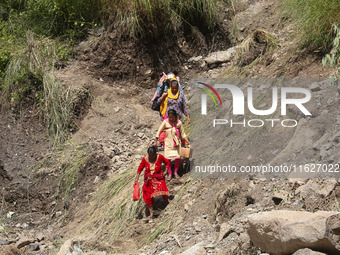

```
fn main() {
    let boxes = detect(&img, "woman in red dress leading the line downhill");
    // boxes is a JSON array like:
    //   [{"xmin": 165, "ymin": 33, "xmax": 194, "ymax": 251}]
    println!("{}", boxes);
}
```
[{"xmin": 135, "ymin": 147, "xmax": 171, "ymax": 218}]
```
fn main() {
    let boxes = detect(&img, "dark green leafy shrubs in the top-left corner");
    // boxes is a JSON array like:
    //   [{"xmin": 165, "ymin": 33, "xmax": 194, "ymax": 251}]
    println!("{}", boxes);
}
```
[{"xmin": 0, "ymin": 0, "xmax": 101, "ymax": 36}]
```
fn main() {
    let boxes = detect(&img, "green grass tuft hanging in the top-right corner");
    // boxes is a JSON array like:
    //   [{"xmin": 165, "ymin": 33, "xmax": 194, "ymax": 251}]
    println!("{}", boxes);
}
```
[{"xmin": 283, "ymin": 0, "xmax": 340, "ymax": 50}]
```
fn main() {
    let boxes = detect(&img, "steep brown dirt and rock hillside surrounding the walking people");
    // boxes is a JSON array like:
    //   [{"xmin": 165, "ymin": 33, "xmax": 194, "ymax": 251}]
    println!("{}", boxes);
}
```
[{"xmin": 0, "ymin": 0, "xmax": 340, "ymax": 255}]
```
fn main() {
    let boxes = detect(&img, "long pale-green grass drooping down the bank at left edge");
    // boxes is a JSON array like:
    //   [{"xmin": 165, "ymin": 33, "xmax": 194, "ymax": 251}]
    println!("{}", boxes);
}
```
[{"xmin": 0, "ymin": 31, "xmax": 90, "ymax": 145}]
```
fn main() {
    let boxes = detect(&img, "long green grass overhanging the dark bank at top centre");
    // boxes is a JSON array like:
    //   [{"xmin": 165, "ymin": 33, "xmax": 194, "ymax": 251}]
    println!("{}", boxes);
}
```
[{"xmin": 102, "ymin": 0, "xmax": 217, "ymax": 39}]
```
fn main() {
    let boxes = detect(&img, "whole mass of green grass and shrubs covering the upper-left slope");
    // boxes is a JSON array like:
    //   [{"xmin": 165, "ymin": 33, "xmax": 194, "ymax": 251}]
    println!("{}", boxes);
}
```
[{"xmin": 0, "ymin": 0, "xmax": 220, "ymax": 144}]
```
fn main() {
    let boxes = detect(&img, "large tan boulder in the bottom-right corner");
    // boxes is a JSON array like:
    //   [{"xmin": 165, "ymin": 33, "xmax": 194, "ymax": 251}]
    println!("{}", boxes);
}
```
[{"xmin": 248, "ymin": 210, "xmax": 340, "ymax": 255}]
